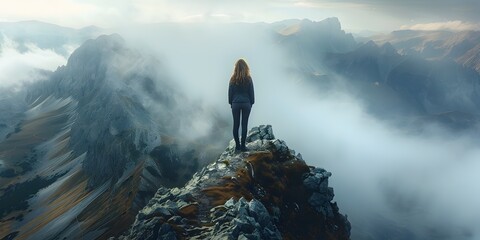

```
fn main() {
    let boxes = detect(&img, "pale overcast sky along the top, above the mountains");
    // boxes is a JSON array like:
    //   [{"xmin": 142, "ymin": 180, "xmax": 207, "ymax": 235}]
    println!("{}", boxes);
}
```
[{"xmin": 0, "ymin": 0, "xmax": 480, "ymax": 31}]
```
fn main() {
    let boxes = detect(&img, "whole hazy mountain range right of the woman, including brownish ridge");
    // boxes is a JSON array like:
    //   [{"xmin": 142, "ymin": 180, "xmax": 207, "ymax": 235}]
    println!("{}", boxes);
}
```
[{"xmin": 280, "ymin": 24, "xmax": 480, "ymax": 129}]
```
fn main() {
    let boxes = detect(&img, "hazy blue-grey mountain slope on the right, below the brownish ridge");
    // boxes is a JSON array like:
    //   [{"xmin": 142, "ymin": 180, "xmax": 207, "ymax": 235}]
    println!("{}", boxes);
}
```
[{"xmin": 286, "ymin": 34, "xmax": 480, "ymax": 129}]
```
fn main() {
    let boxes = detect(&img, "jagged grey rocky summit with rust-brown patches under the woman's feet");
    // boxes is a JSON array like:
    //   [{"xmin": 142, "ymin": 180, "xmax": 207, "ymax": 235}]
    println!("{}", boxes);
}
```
[{"xmin": 119, "ymin": 125, "xmax": 351, "ymax": 239}]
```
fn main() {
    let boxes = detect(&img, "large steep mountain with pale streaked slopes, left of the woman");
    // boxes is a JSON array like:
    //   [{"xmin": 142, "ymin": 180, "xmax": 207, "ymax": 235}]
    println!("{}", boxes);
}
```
[{"xmin": 0, "ymin": 35, "xmax": 225, "ymax": 239}]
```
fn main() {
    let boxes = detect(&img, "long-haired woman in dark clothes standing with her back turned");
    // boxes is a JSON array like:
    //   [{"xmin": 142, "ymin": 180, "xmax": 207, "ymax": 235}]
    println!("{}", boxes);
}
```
[{"xmin": 228, "ymin": 59, "xmax": 255, "ymax": 152}]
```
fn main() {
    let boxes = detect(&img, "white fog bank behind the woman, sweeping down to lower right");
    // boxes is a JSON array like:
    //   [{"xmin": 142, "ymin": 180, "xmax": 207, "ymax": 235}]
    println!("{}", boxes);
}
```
[{"xmin": 116, "ymin": 24, "xmax": 480, "ymax": 239}]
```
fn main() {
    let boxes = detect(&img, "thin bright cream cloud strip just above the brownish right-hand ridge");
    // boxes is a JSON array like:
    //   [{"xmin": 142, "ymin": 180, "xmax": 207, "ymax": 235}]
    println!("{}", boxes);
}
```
[{"xmin": 401, "ymin": 20, "xmax": 480, "ymax": 31}]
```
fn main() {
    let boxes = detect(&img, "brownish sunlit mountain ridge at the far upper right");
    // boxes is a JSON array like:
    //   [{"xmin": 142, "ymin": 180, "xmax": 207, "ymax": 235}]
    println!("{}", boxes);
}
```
[{"xmin": 372, "ymin": 30, "xmax": 480, "ymax": 72}]
